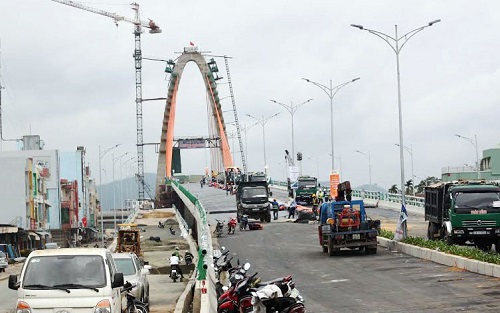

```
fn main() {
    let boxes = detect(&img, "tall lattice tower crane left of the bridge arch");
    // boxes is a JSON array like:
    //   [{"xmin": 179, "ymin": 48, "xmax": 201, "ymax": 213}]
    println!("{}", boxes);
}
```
[{"xmin": 47, "ymin": 0, "xmax": 161, "ymax": 200}]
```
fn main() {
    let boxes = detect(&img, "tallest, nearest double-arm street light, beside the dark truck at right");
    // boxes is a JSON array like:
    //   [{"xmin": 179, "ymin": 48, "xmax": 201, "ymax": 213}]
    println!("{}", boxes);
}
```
[{"xmin": 351, "ymin": 20, "xmax": 441, "ymax": 238}]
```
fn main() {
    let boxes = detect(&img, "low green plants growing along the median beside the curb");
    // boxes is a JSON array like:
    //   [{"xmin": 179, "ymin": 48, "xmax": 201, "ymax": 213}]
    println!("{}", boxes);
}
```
[{"xmin": 379, "ymin": 229, "xmax": 500, "ymax": 264}]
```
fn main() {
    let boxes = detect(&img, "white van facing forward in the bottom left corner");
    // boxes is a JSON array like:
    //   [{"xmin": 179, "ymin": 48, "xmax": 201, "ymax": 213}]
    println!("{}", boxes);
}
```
[{"xmin": 9, "ymin": 248, "xmax": 123, "ymax": 313}]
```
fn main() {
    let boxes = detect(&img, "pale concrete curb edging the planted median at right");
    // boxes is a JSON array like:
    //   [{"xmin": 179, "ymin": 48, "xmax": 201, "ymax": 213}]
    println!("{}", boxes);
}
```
[{"xmin": 377, "ymin": 237, "xmax": 500, "ymax": 278}]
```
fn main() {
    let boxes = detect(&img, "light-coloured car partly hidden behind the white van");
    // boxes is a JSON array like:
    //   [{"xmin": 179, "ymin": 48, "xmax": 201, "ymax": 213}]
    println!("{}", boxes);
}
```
[{"xmin": 112, "ymin": 252, "xmax": 151, "ymax": 306}]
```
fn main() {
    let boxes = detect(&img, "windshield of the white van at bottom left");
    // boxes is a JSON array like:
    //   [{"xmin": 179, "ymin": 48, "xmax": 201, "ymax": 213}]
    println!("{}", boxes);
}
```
[{"xmin": 23, "ymin": 255, "xmax": 106, "ymax": 289}]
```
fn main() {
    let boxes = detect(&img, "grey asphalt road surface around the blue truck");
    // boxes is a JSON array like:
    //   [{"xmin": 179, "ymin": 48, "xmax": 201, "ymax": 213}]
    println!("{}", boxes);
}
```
[{"xmin": 185, "ymin": 184, "xmax": 500, "ymax": 313}]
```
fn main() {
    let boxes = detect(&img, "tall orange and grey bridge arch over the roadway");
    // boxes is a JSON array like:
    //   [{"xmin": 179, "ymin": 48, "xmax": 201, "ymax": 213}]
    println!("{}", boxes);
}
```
[{"xmin": 155, "ymin": 48, "xmax": 233, "ymax": 195}]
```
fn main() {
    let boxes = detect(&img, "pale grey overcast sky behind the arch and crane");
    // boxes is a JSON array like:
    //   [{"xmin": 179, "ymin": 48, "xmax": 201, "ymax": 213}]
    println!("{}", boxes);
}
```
[{"xmin": 0, "ymin": 0, "xmax": 500, "ymax": 188}]
